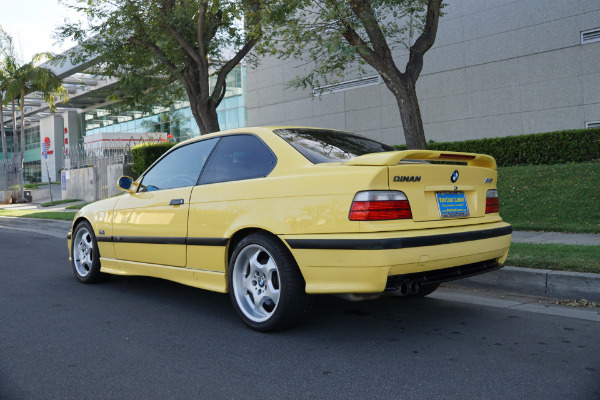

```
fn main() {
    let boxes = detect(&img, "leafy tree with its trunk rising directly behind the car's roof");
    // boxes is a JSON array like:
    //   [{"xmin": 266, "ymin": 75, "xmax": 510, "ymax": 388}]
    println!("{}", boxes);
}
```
[{"xmin": 59, "ymin": 0, "xmax": 271, "ymax": 134}]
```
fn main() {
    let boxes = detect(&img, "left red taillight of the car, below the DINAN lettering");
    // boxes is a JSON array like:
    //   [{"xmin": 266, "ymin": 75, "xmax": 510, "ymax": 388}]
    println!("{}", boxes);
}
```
[{"xmin": 350, "ymin": 190, "xmax": 412, "ymax": 221}]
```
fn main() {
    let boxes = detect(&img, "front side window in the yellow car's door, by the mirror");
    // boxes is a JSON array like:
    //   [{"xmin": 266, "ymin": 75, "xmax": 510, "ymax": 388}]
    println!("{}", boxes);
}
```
[{"xmin": 138, "ymin": 138, "xmax": 218, "ymax": 192}]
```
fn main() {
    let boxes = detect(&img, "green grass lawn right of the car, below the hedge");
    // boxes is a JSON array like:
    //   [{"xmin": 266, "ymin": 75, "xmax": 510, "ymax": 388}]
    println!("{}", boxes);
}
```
[{"xmin": 498, "ymin": 162, "xmax": 600, "ymax": 233}]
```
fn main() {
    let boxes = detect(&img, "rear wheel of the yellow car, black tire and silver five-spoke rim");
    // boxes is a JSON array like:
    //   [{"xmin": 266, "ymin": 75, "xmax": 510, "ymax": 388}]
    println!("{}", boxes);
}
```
[{"xmin": 229, "ymin": 233, "xmax": 312, "ymax": 332}]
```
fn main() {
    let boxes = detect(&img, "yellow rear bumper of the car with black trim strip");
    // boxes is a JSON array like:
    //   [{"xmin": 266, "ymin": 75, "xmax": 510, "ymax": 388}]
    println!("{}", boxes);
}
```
[{"xmin": 281, "ymin": 222, "xmax": 512, "ymax": 293}]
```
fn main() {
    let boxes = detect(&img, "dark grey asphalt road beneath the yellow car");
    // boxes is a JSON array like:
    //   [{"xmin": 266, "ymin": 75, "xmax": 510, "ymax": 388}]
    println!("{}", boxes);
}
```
[{"xmin": 0, "ymin": 228, "xmax": 600, "ymax": 400}]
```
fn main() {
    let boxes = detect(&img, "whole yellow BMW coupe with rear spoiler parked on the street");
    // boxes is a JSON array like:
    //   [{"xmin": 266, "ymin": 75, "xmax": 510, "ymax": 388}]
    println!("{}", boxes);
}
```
[{"xmin": 68, "ymin": 127, "xmax": 512, "ymax": 331}]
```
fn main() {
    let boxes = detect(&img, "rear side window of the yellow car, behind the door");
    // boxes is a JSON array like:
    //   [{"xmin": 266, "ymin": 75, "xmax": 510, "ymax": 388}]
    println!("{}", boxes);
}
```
[{"xmin": 200, "ymin": 135, "xmax": 277, "ymax": 184}]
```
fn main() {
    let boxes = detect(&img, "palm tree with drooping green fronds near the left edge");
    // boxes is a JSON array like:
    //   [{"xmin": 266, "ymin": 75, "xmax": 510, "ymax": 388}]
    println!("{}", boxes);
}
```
[{"xmin": 5, "ymin": 53, "xmax": 68, "ymax": 197}]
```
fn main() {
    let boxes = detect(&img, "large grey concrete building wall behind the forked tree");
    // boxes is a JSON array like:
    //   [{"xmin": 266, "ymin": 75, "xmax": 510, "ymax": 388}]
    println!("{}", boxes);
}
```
[{"xmin": 246, "ymin": 0, "xmax": 600, "ymax": 144}]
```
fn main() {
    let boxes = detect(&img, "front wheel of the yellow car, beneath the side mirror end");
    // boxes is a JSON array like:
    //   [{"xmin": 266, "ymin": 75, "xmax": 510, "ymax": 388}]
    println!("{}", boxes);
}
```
[{"xmin": 71, "ymin": 221, "xmax": 106, "ymax": 283}]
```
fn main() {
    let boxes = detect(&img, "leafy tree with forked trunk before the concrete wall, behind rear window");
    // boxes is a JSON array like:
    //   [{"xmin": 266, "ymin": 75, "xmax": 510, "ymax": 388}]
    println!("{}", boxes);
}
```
[{"xmin": 260, "ymin": 0, "xmax": 442, "ymax": 149}]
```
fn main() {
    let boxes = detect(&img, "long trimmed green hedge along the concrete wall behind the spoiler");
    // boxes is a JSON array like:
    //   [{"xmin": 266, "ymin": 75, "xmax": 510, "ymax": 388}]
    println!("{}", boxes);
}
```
[{"xmin": 394, "ymin": 128, "xmax": 600, "ymax": 167}]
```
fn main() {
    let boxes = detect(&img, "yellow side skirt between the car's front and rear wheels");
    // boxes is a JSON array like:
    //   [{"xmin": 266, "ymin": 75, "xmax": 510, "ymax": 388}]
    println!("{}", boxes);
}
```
[{"xmin": 100, "ymin": 257, "xmax": 227, "ymax": 293}]
